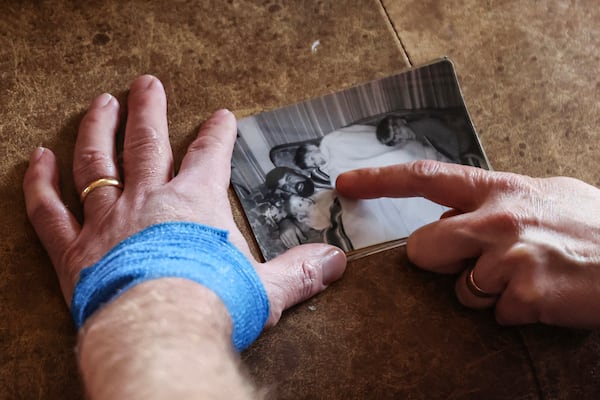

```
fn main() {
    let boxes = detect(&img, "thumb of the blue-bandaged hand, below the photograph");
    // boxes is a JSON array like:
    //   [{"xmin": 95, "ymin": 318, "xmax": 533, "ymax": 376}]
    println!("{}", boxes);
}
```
[{"xmin": 256, "ymin": 243, "xmax": 346, "ymax": 327}]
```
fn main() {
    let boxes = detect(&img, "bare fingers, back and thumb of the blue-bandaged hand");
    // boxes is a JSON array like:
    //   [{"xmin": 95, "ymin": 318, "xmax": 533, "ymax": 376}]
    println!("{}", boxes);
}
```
[{"xmin": 23, "ymin": 76, "xmax": 346, "ymax": 326}]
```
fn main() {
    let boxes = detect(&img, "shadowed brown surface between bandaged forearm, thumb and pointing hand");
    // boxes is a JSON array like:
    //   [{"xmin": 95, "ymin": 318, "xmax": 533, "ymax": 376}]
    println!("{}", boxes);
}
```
[{"xmin": 244, "ymin": 250, "xmax": 538, "ymax": 399}]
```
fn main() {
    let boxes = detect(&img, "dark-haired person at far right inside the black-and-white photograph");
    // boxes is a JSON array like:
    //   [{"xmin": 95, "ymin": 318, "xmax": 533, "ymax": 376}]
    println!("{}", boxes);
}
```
[{"xmin": 376, "ymin": 115, "xmax": 460, "ymax": 163}]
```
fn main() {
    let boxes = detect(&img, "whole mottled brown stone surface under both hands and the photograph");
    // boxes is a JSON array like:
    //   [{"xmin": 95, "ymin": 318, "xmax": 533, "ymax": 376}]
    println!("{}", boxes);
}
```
[{"xmin": 0, "ymin": 0, "xmax": 598, "ymax": 399}]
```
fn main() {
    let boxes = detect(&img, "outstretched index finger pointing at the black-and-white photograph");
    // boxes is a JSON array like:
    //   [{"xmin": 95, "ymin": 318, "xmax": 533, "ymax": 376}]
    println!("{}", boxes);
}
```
[{"xmin": 336, "ymin": 160, "xmax": 492, "ymax": 211}]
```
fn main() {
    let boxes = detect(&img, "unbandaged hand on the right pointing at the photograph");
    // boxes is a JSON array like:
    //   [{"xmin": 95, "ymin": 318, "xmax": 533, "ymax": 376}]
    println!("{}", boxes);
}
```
[{"xmin": 336, "ymin": 160, "xmax": 600, "ymax": 328}]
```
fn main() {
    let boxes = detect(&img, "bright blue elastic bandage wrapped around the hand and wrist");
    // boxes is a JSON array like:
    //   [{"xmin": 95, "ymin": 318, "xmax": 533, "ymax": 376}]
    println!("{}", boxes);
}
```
[{"xmin": 71, "ymin": 222, "xmax": 269, "ymax": 351}]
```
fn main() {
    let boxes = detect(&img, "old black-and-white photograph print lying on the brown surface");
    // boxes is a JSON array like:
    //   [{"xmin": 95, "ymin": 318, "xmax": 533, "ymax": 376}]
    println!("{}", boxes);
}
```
[{"xmin": 231, "ymin": 59, "xmax": 490, "ymax": 260}]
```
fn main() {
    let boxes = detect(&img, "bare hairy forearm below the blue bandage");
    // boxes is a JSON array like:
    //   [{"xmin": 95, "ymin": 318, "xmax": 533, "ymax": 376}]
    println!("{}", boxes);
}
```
[{"xmin": 78, "ymin": 278, "xmax": 258, "ymax": 399}]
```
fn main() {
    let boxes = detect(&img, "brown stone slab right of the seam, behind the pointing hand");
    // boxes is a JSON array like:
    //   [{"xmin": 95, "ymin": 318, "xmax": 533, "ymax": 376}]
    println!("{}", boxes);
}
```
[{"xmin": 384, "ymin": 0, "xmax": 600, "ymax": 399}]
